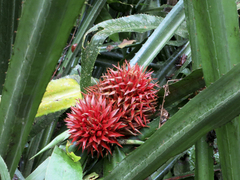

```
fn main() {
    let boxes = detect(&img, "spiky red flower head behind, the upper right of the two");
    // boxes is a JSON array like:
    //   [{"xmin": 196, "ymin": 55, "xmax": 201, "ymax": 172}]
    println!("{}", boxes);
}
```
[{"xmin": 89, "ymin": 61, "xmax": 159, "ymax": 135}]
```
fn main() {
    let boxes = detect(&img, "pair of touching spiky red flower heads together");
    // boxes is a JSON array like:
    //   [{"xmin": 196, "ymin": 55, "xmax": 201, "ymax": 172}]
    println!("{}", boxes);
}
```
[{"xmin": 65, "ymin": 61, "xmax": 158, "ymax": 156}]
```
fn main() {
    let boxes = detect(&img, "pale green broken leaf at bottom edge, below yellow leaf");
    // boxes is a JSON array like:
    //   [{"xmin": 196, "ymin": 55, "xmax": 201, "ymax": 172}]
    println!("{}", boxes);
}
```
[{"xmin": 45, "ymin": 146, "xmax": 83, "ymax": 180}]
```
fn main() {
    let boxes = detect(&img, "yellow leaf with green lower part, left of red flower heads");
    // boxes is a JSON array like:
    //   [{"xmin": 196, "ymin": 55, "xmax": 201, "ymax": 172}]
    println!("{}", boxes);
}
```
[{"xmin": 28, "ymin": 76, "xmax": 82, "ymax": 139}]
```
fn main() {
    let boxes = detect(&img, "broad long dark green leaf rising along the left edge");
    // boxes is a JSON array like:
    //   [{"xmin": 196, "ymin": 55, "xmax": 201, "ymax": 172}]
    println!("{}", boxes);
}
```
[{"xmin": 0, "ymin": 0, "xmax": 82, "ymax": 176}]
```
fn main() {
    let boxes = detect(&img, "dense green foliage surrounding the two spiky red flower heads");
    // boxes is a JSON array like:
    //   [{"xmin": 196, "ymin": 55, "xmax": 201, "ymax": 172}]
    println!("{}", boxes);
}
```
[{"xmin": 0, "ymin": 0, "xmax": 240, "ymax": 180}]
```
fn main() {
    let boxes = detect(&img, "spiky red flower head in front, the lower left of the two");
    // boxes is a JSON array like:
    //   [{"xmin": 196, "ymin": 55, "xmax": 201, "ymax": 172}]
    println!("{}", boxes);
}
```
[{"xmin": 65, "ymin": 93, "xmax": 126, "ymax": 156}]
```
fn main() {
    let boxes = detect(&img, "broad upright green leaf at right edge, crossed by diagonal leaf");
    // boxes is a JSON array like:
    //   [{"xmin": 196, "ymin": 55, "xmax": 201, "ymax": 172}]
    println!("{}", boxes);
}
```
[{"xmin": 192, "ymin": 0, "xmax": 240, "ymax": 179}]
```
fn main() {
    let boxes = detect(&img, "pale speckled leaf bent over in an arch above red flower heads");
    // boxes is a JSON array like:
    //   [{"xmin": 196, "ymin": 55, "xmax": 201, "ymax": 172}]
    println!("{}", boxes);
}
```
[{"xmin": 80, "ymin": 14, "xmax": 162, "ymax": 92}]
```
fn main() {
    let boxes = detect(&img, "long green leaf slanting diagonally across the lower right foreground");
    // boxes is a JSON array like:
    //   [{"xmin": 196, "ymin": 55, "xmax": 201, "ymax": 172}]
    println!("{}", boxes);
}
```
[{"xmin": 104, "ymin": 64, "xmax": 240, "ymax": 180}]
